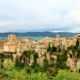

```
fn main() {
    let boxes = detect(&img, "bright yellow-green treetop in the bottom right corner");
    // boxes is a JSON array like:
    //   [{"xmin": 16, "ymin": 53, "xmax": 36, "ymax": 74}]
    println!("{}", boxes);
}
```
[{"xmin": 53, "ymin": 70, "xmax": 80, "ymax": 80}]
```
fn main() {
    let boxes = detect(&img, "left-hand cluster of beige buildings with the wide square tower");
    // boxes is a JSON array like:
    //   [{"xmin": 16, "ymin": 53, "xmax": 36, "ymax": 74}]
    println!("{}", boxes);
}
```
[{"xmin": 3, "ymin": 34, "xmax": 35, "ymax": 53}]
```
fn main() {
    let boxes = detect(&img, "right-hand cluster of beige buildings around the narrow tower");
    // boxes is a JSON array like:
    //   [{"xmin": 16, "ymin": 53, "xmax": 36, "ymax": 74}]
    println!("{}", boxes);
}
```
[{"xmin": 39, "ymin": 34, "xmax": 80, "ymax": 48}]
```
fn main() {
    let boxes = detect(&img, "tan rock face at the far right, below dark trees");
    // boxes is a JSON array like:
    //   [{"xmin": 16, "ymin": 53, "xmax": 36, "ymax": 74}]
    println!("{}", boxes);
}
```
[{"xmin": 66, "ymin": 51, "xmax": 80, "ymax": 71}]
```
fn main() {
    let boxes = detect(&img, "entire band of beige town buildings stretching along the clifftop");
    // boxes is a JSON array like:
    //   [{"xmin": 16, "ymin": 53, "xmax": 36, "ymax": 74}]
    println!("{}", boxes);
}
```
[{"xmin": 0, "ymin": 34, "xmax": 80, "ymax": 54}]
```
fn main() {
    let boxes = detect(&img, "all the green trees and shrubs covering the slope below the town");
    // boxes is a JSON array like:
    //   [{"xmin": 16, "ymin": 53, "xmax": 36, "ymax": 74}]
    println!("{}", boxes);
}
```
[{"xmin": 0, "ymin": 40, "xmax": 80, "ymax": 80}]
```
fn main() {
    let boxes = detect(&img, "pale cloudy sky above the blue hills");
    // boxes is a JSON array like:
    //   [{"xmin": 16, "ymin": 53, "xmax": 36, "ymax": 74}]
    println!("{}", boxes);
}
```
[{"xmin": 0, "ymin": 0, "xmax": 80, "ymax": 33}]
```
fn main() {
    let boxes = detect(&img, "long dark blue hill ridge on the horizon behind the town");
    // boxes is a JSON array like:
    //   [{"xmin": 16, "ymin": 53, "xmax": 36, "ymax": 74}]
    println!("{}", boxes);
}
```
[{"xmin": 0, "ymin": 32, "xmax": 79, "ymax": 37}]
